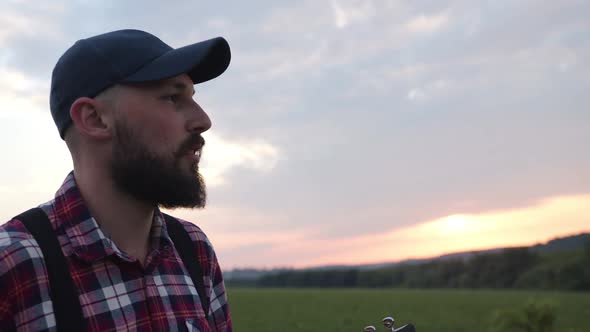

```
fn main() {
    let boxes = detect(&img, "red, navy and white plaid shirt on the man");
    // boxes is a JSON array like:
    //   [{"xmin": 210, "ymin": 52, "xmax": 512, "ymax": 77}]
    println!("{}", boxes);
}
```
[{"xmin": 0, "ymin": 173, "xmax": 232, "ymax": 332}]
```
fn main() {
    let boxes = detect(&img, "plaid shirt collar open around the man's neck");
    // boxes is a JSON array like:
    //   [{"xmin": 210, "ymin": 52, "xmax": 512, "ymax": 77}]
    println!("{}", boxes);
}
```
[{"xmin": 54, "ymin": 172, "xmax": 172, "ymax": 262}]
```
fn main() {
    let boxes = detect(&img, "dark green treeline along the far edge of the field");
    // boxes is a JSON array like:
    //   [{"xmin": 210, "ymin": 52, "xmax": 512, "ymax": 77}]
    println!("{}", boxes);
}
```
[{"xmin": 229, "ymin": 242, "xmax": 590, "ymax": 290}]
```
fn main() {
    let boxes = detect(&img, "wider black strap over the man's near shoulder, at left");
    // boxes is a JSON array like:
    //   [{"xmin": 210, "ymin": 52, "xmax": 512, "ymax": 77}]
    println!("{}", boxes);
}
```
[{"xmin": 14, "ymin": 208, "xmax": 87, "ymax": 331}]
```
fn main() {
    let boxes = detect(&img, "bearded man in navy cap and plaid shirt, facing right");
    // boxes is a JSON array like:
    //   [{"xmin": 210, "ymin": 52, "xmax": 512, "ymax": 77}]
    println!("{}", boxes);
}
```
[{"xmin": 0, "ymin": 30, "xmax": 232, "ymax": 331}]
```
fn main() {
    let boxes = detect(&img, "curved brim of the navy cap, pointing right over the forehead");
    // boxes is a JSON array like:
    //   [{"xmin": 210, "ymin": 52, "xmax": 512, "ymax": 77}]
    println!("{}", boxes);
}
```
[{"xmin": 123, "ymin": 37, "xmax": 231, "ymax": 84}]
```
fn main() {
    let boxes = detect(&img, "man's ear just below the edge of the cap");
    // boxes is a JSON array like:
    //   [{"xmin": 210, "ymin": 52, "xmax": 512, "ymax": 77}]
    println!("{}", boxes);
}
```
[{"xmin": 70, "ymin": 97, "xmax": 112, "ymax": 140}]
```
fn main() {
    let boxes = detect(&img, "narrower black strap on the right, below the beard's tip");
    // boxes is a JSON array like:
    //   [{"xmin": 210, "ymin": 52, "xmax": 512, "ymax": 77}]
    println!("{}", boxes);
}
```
[{"xmin": 163, "ymin": 213, "xmax": 209, "ymax": 321}]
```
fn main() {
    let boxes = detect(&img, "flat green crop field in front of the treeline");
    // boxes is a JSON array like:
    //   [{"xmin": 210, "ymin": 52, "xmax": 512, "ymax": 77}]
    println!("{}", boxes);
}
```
[{"xmin": 229, "ymin": 288, "xmax": 590, "ymax": 332}]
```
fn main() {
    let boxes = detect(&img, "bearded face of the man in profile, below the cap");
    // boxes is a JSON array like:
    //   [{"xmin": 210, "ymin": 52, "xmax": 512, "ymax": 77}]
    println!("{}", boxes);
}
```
[{"xmin": 111, "ymin": 75, "xmax": 211, "ymax": 208}]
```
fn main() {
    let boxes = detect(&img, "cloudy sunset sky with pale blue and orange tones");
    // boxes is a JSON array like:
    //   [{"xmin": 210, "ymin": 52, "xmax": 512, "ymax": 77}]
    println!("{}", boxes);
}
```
[{"xmin": 0, "ymin": 0, "xmax": 590, "ymax": 270}]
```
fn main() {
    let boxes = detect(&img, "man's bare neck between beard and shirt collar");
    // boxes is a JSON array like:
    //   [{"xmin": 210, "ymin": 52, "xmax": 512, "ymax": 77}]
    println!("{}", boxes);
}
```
[{"xmin": 74, "ymin": 166, "xmax": 155, "ymax": 264}]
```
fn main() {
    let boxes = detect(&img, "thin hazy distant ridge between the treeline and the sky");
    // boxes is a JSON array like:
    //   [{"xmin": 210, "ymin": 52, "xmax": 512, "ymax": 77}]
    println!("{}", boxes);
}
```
[{"xmin": 224, "ymin": 233, "xmax": 590, "ymax": 281}]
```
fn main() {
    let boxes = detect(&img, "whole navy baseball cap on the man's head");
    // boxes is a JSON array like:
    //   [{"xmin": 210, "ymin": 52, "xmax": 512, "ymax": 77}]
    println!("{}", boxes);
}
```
[{"xmin": 49, "ymin": 30, "xmax": 231, "ymax": 139}]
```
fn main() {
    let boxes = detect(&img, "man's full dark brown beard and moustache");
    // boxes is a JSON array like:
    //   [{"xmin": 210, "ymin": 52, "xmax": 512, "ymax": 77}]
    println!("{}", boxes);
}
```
[{"xmin": 111, "ymin": 122, "xmax": 207, "ymax": 208}]
